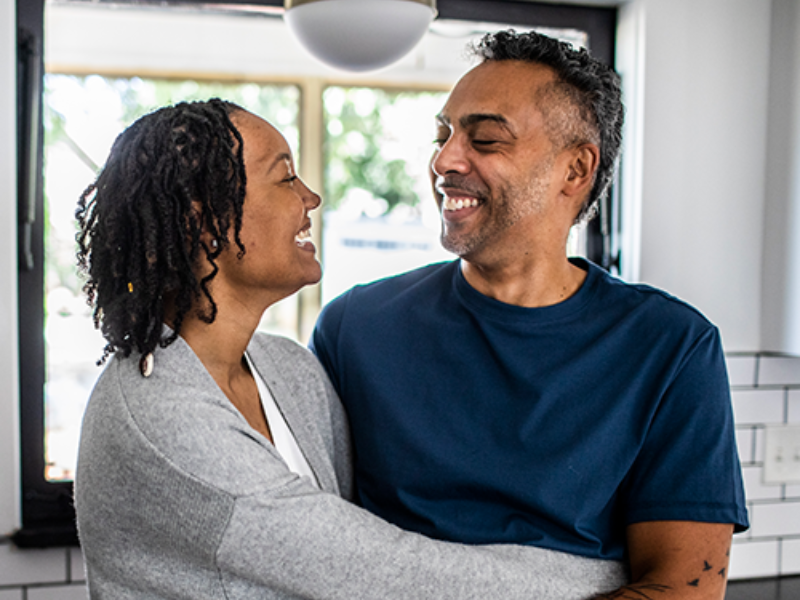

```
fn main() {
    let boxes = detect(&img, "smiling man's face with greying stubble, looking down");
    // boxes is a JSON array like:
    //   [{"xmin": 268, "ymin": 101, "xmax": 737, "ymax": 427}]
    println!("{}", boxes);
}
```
[{"xmin": 431, "ymin": 61, "xmax": 558, "ymax": 261}]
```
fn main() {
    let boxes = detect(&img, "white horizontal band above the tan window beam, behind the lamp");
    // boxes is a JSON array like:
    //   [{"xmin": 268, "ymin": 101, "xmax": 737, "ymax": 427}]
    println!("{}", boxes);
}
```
[{"xmin": 45, "ymin": 4, "xmax": 472, "ymax": 89}]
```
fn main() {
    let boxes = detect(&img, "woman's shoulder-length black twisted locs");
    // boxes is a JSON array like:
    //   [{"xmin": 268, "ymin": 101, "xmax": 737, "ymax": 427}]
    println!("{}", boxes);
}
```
[{"xmin": 75, "ymin": 98, "xmax": 247, "ymax": 364}]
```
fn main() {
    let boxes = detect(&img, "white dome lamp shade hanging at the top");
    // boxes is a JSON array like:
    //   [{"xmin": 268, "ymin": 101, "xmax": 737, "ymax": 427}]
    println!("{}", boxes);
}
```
[{"xmin": 284, "ymin": 0, "xmax": 436, "ymax": 72}]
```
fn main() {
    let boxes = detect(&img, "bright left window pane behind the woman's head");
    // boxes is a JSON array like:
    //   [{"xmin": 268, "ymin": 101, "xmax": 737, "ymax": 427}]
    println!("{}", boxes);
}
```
[{"xmin": 44, "ymin": 74, "xmax": 300, "ymax": 481}]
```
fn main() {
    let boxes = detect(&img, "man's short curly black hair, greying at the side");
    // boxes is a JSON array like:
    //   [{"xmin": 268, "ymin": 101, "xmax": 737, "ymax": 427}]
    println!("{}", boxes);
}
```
[{"xmin": 472, "ymin": 30, "xmax": 625, "ymax": 222}]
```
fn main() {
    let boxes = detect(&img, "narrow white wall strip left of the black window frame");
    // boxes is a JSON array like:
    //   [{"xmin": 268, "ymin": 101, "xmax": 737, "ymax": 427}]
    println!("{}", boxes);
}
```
[{"xmin": 0, "ymin": 0, "xmax": 19, "ymax": 535}]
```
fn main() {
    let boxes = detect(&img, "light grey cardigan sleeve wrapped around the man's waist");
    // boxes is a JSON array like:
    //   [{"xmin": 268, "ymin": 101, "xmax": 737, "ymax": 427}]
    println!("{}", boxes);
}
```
[{"xmin": 218, "ymin": 481, "xmax": 627, "ymax": 600}]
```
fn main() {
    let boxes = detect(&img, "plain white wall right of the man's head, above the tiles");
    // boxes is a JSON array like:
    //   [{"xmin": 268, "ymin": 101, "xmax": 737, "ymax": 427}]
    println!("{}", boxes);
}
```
[{"xmin": 622, "ymin": 0, "xmax": 772, "ymax": 351}]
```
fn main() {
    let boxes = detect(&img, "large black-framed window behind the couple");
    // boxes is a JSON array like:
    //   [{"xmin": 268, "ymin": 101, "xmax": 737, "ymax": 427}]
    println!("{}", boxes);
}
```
[{"xmin": 16, "ymin": 0, "xmax": 615, "ymax": 546}]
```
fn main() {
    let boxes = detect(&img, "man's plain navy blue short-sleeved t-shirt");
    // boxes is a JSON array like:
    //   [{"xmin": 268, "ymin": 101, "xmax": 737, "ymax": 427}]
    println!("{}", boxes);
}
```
[{"xmin": 311, "ymin": 259, "xmax": 747, "ymax": 560}]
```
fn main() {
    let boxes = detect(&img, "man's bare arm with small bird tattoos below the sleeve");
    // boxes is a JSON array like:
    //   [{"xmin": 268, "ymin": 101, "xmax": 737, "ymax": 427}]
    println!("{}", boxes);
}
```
[{"xmin": 595, "ymin": 521, "xmax": 733, "ymax": 600}]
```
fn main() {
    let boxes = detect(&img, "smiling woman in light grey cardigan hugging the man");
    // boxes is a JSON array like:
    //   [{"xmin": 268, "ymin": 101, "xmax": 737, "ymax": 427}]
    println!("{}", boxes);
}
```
[{"xmin": 75, "ymin": 100, "xmax": 618, "ymax": 600}]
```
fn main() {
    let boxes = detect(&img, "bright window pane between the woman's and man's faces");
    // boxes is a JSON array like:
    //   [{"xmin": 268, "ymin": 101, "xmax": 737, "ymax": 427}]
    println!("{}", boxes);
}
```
[{"xmin": 322, "ymin": 87, "xmax": 453, "ymax": 304}]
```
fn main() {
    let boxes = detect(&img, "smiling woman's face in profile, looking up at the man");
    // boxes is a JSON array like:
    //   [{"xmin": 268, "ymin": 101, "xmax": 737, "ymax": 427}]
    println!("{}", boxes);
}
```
[{"xmin": 218, "ymin": 111, "xmax": 322, "ymax": 304}]
